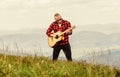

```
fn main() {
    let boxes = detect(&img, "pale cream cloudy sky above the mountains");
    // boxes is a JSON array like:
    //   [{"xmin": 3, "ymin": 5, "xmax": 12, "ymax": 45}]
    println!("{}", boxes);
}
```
[{"xmin": 0, "ymin": 0, "xmax": 120, "ymax": 33}]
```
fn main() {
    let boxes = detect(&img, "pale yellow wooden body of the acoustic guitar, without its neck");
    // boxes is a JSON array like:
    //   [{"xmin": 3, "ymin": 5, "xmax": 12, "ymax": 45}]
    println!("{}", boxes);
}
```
[{"xmin": 48, "ymin": 31, "xmax": 64, "ymax": 47}]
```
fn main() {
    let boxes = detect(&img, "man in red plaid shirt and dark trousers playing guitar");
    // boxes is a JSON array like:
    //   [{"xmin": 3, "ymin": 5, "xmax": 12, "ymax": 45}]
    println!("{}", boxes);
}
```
[{"xmin": 46, "ymin": 13, "xmax": 72, "ymax": 61}]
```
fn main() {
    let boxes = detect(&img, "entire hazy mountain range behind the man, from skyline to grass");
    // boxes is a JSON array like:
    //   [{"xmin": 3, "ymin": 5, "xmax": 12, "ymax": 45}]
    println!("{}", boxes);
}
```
[{"xmin": 0, "ymin": 29, "xmax": 120, "ymax": 66}]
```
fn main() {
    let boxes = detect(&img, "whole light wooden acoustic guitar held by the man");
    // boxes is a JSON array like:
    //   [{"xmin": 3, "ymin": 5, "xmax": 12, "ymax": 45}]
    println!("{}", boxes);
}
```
[{"xmin": 48, "ymin": 26, "xmax": 76, "ymax": 48}]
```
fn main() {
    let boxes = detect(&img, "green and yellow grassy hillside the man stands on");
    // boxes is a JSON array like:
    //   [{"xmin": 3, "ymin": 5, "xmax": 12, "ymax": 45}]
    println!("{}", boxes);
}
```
[{"xmin": 0, "ymin": 54, "xmax": 120, "ymax": 77}]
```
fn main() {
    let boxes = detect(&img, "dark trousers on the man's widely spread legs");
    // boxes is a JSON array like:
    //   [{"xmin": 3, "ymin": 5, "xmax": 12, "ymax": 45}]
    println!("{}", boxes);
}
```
[{"xmin": 53, "ymin": 44, "xmax": 72, "ymax": 61}]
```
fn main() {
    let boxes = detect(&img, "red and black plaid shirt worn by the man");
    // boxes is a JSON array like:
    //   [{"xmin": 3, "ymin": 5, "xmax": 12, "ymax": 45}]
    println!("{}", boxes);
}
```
[{"xmin": 46, "ymin": 20, "xmax": 72, "ymax": 45}]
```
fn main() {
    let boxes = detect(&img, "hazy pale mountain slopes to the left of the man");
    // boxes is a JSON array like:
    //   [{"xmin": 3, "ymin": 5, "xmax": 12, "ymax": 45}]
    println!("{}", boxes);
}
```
[{"xmin": 0, "ymin": 29, "xmax": 49, "ymax": 53}]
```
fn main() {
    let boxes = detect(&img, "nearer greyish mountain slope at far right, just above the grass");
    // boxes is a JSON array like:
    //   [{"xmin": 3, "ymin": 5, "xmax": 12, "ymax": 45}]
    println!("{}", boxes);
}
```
[{"xmin": 77, "ymin": 49, "xmax": 120, "ymax": 68}]
